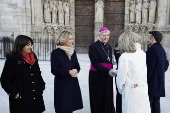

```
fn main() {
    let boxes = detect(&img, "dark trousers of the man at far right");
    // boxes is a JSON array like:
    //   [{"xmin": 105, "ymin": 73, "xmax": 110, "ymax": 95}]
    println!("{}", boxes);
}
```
[{"xmin": 149, "ymin": 97, "xmax": 161, "ymax": 113}]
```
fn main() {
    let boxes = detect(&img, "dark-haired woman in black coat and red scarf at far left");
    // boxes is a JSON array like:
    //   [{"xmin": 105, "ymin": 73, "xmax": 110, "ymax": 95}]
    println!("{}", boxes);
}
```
[{"xmin": 1, "ymin": 35, "xmax": 45, "ymax": 113}]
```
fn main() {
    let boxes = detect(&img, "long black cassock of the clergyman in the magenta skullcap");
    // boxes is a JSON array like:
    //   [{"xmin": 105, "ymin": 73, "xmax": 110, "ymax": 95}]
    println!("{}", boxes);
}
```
[{"xmin": 89, "ymin": 40, "xmax": 115, "ymax": 113}]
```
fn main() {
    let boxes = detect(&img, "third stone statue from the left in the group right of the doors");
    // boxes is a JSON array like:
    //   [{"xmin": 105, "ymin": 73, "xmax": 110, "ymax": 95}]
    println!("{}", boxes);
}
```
[{"xmin": 142, "ymin": 0, "xmax": 149, "ymax": 24}]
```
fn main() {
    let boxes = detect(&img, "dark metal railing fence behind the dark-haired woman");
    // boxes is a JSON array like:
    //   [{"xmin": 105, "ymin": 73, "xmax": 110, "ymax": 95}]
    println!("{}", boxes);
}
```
[{"xmin": 0, "ymin": 36, "xmax": 56, "ymax": 61}]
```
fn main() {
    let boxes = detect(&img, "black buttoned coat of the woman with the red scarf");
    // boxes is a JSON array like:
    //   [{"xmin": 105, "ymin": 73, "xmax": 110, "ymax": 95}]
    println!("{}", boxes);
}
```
[{"xmin": 1, "ymin": 55, "xmax": 45, "ymax": 113}]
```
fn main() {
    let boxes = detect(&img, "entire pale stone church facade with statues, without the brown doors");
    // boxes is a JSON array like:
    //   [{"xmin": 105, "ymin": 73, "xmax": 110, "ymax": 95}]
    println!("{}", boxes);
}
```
[{"xmin": 0, "ymin": 0, "xmax": 170, "ymax": 59}]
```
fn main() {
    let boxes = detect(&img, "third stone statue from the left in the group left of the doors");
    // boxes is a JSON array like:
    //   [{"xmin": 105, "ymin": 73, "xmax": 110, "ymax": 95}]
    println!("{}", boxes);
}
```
[{"xmin": 58, "ymin": 1, "xmax": 64, "ymax": 24}]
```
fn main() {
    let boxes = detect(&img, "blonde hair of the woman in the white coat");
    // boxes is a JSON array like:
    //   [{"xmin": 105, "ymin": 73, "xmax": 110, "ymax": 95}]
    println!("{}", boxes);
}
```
[{"xmin": 116, "ymin": 31, "xmax": 141, "ymax": 53}]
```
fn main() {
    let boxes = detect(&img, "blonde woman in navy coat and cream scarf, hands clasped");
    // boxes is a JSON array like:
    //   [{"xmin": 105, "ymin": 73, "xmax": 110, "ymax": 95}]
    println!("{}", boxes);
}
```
[{"xmin": 51, "ymin": 31, "xmax": 83, "ymax": 113}]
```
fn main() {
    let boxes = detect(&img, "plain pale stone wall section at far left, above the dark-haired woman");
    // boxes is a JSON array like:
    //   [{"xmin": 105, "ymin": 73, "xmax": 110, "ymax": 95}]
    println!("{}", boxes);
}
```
[{"xmin": 0, "ymin": 0, "xmax": 31, "ymax": 36}]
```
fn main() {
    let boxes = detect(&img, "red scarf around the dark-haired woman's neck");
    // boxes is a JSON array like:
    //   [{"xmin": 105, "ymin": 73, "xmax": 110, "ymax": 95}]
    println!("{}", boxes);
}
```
[{"xmin": 22, "ymin": 52, "xmax": 35, "ymax": 65}]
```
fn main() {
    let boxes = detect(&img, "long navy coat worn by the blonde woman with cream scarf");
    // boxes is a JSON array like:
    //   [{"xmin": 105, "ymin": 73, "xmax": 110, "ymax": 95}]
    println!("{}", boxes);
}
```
[{"xmin": 51, "ymin": 48, "xmax": 83, "ymax": 113}]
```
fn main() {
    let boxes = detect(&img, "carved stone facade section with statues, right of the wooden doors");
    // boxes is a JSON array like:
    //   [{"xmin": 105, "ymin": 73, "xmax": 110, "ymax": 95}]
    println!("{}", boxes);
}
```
[{"xmin": 125, "ymin": 0, "xmax": 170, "ymax": 60}]
